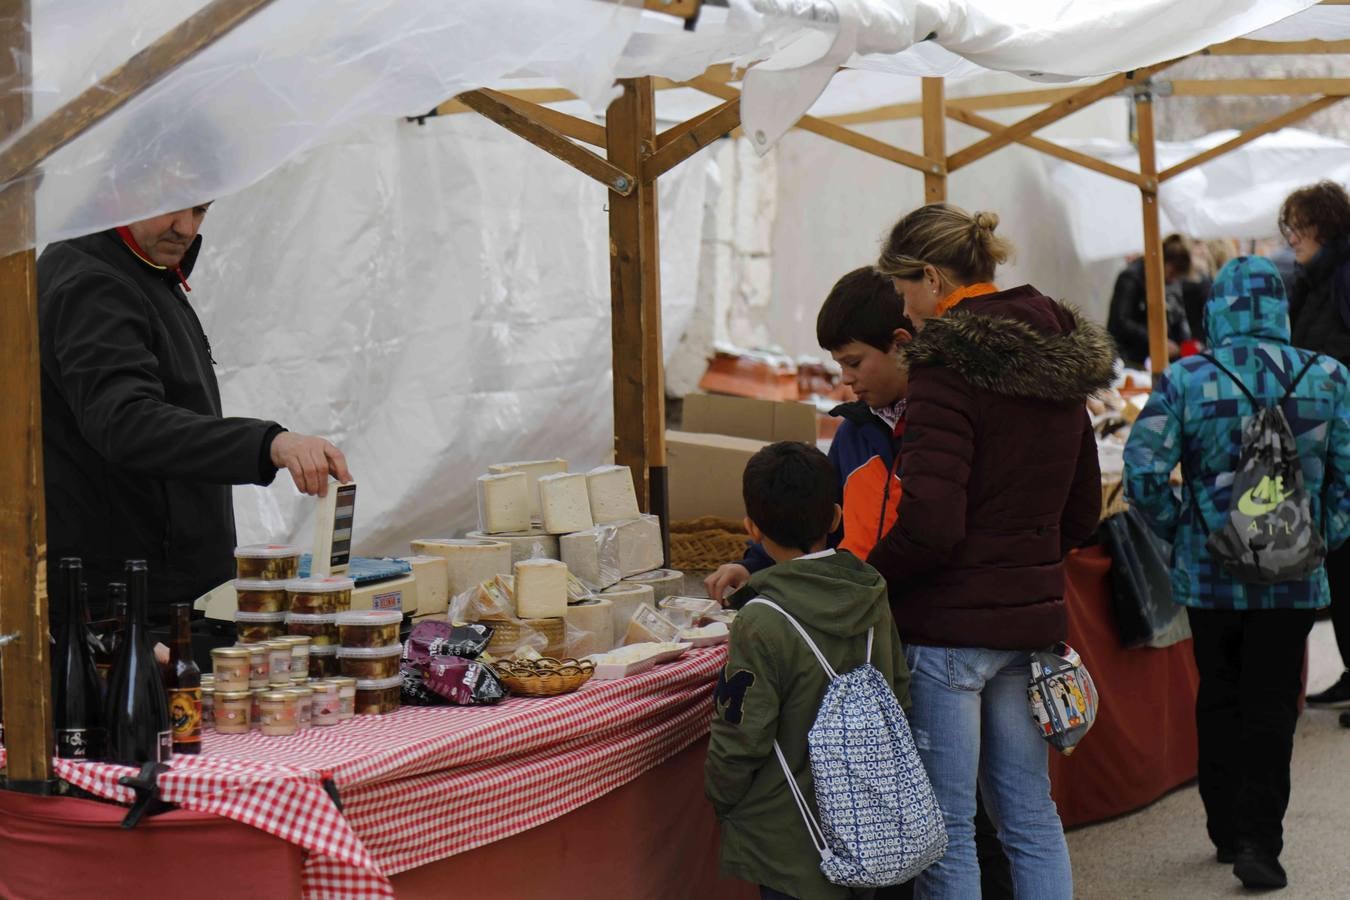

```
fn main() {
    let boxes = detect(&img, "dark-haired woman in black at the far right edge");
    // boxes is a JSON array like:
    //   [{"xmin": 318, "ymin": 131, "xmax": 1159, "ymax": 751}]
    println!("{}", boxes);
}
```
[{"xmin": 1280, "ymin": 181, "xmax": 1350, "ymax": 712}]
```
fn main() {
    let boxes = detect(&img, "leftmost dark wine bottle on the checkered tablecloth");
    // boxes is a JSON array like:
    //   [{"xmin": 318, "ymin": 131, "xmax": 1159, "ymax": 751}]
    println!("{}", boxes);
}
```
[{"xmin": 51, "ymin": 556, "xmax": 105, "ymax": 760}]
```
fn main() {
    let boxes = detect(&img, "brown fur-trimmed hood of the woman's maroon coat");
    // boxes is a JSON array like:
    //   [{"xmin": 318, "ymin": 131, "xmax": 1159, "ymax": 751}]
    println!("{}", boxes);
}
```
[{"xmin": 903, "ymin": 285, "xmax": 1115, "ymax": 402}]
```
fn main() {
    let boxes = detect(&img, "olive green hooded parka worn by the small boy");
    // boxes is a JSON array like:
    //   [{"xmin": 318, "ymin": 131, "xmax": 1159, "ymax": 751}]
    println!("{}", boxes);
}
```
[{"xmin": 705, "ymin": 552, "xmax": 910, "ymax": 900}]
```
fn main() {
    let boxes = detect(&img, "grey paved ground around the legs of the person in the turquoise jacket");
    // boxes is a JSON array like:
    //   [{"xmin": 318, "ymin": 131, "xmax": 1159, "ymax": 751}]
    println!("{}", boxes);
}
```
[{"xmin": 1069, "ymin": 622, "xmax": 1350, "ymax": 900}]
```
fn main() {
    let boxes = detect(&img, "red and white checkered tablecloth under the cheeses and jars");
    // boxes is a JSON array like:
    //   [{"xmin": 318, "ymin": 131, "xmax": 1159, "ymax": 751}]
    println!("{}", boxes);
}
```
[{"xmin": 34, "ymin": 648, "xmax": 726, "ymax": 900}]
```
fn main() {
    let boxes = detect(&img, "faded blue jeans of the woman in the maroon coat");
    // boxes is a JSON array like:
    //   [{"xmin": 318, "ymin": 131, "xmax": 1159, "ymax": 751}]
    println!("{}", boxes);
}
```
[{"xmin": 905, "ymin": 645, "xmax": 1073, "ymax": 900}]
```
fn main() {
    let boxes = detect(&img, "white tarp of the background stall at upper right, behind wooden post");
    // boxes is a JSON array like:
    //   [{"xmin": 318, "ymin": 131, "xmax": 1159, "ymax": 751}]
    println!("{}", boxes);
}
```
[{"xmin": 1044, "ymin": 128, "xmax": 1350, "ymax": 260}]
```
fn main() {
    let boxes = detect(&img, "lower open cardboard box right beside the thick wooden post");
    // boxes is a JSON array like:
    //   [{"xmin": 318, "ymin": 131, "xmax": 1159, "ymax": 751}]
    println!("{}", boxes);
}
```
[{"xmin": 666, "ymin": 432, "xmax": 768, "ymax": 521}]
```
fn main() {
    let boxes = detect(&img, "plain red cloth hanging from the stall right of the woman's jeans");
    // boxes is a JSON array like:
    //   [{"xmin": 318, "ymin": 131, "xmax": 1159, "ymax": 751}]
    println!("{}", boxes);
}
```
[{"xmin": 1050, "ymin": 548, "xmax": 1200, "ymax": 826}]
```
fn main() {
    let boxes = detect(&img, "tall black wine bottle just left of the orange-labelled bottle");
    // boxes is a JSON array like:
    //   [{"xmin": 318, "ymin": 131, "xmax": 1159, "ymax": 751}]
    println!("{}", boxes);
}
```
[{"xmin": 107, "ymin": 560, "xmax": 173, "ymax": 765}]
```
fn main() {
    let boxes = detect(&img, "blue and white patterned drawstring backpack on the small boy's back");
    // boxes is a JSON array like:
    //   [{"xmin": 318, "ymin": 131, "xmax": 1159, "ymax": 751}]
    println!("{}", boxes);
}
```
[{"xmin": 747, "ymin": 596, "xmax": 946, "ymax": 888}]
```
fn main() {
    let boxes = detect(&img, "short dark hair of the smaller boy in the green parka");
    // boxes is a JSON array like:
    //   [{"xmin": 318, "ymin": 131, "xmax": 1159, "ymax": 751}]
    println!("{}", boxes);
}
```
[{"xmin": 741, "ymin": 441, "xmax": 837, "ymax": 553}]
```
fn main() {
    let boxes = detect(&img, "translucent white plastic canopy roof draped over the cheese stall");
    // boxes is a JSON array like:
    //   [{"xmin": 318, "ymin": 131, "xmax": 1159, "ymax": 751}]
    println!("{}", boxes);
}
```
[{"xmin": 10, "ymin": 0, "xmax": 1350, "ymax": 252}]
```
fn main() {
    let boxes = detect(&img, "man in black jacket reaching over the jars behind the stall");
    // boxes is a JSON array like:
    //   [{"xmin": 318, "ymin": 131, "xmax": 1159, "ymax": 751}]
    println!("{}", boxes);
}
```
[{"xmin": 38, "ymin": 204, "xmax": 351, "ymax": 623}]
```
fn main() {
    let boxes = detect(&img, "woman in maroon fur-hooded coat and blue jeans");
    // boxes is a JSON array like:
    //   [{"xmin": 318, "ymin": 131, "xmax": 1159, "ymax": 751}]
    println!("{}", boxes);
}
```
[{"xmin": 868, "ymin": 204, "xmax": 1115, "ymax": 900}]
